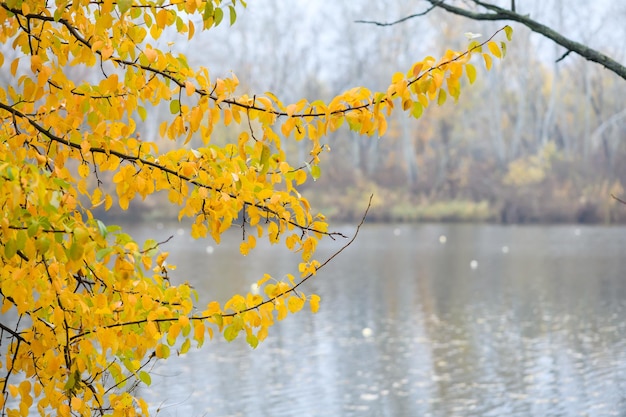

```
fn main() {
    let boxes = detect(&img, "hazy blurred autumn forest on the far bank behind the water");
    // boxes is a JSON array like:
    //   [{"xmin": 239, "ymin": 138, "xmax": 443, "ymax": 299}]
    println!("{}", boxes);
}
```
[{"xmin": 6, "ymin": 0, "xmax": 626, "ymax": 223}]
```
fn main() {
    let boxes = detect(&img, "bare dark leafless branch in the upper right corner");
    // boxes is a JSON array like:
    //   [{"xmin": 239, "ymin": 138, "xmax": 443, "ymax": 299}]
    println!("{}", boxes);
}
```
[{"xmin": 362, "ymin": 0, "xmax": 626, "ymax": 80}]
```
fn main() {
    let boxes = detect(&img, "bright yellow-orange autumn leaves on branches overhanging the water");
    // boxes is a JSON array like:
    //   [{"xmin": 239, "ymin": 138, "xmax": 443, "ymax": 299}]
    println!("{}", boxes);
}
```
[{"xmin": 0, "ymin": 0, "xmax": 510, "ymax": 416}]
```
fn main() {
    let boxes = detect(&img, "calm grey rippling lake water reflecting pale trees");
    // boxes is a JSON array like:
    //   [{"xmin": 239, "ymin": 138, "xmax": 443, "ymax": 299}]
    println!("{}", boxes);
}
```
[{"xmin": 128, "ymin": 225, "xmax": 626, "ymax": 417}]
